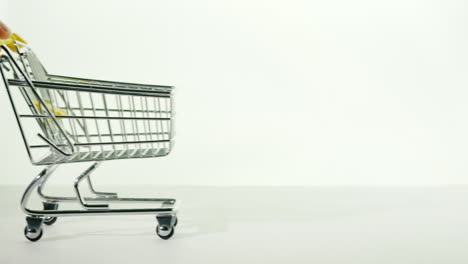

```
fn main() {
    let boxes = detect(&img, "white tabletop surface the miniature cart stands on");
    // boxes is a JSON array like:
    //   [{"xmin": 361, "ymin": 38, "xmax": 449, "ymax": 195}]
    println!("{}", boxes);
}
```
[{"xmin": 0, "ymin": 186, "xmax": 468, "ymax": 264}]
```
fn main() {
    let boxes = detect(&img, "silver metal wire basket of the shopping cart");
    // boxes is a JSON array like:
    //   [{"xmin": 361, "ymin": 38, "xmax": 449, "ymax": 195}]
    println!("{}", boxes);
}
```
[{"xmin": 0, "ymin": 42, "xmax": 174, "ymax": 165}]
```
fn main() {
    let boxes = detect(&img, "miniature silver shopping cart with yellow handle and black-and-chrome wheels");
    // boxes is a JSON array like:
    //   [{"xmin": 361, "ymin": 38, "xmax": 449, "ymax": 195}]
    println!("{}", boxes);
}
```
[{"xmin": 0, "ymin": 35, "xmax": 177, "ymax": 241}]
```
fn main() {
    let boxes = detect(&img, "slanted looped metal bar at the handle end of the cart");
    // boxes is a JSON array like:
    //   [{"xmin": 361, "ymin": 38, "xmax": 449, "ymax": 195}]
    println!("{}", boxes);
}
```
[{"xmin": 1, "ymin": 41, "xmax": 75, "ymax": 156}]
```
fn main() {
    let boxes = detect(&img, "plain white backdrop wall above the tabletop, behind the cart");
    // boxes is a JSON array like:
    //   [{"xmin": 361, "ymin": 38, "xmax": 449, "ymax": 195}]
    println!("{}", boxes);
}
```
[{"xmin": 0, "ymin": 0, "xmax": 468, "ymax": 186}]
